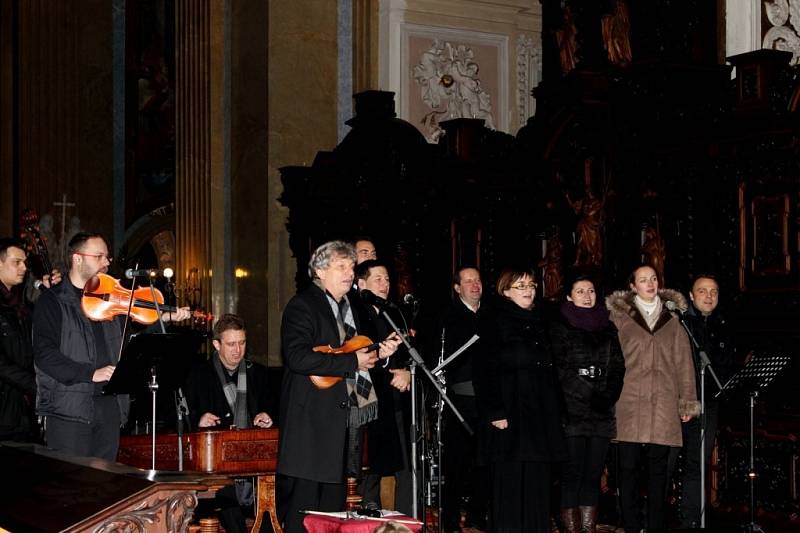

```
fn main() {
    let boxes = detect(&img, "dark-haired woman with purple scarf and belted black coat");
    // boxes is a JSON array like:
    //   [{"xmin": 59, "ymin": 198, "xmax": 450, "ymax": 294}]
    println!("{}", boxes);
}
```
[{"xmin": 550, "ymin": 277, "xmax": 625, "ymax": 533}]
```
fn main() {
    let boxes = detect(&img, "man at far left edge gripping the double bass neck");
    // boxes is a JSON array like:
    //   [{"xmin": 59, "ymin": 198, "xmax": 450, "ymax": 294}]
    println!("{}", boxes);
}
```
[{"xmin": 0, "ymin": 239, "xmax": 61, "ymax": 442}]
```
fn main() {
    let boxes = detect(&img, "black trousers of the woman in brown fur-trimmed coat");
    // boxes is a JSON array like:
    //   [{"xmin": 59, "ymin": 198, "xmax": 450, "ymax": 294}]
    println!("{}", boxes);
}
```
[{"xmin": 617, "ymin": 442, "xmax": 670, "ymax": 532}]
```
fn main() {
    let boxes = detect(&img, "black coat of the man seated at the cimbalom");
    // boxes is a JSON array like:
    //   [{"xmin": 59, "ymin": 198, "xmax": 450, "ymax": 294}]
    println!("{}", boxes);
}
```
[{"xmin": 183, "ymin": 352, "xmax": 269, "ymax": 430}]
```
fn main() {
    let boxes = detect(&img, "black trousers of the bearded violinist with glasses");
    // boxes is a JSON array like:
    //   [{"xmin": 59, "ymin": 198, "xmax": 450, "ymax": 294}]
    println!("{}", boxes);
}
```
[{"xmin": 45, "ymin": 396, "xmax": 120, "ymax": 461}]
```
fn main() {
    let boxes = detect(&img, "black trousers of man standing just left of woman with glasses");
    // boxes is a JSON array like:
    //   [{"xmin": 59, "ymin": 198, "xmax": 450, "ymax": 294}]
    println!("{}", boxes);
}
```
[{"xmin": 442, "ymin": 394, "xmax": 487, "ymax": 531}]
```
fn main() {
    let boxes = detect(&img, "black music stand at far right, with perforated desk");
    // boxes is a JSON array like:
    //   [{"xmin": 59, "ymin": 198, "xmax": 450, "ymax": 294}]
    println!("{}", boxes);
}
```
[{"xmin": 715, "ymin": 355, "xmax": 792, "ymax": 533}]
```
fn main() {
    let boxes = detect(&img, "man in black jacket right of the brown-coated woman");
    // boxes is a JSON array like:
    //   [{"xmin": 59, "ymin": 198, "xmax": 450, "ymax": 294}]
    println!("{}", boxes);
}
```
[{"xmin": 680, "ymin": 275, "xmax": 736, "ymax": 528}]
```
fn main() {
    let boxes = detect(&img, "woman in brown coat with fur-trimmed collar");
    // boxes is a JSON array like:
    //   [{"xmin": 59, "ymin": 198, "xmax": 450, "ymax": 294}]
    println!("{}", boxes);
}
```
[{"xmin": 606, "ymin": 265, "xmax": 700, "ymax": 531}]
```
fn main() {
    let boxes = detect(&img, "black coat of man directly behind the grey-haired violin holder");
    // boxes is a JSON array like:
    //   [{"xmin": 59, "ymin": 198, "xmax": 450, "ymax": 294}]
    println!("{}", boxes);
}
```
[{"xmin": 354, "ymin": 304, "xmax": 411, "ymax": 475}]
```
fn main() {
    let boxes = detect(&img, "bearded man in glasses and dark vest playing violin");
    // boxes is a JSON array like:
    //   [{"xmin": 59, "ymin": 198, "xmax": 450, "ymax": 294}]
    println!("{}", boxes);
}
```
[{"xmin": 33, "ymin": 232, "xmax": 190, "ymax": 461}]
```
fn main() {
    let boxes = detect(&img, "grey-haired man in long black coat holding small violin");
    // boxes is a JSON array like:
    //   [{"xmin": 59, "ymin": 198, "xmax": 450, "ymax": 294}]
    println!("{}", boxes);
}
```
[{"xmin": 276, "ymin": 241, "xmax": 400, "ymax": 533}]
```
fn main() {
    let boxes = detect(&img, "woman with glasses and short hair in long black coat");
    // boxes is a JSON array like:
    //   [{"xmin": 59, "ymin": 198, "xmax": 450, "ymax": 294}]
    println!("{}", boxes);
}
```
[{"xmin": 473, "ymin": 269, "xmax": 566, "ymax": 533}]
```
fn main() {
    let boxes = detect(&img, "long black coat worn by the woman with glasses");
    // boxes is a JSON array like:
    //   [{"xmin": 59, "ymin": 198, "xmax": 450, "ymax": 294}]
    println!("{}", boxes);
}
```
[{"xmin": 473, "ymin": 298, "xmax": 567, "ymax": 462}]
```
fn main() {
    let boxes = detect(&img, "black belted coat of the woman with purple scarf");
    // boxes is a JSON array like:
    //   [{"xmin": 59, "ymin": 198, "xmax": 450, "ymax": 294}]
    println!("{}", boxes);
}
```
[{"xmin": 550, "ymin": 313, "xmax": 625, "ymax": 438}]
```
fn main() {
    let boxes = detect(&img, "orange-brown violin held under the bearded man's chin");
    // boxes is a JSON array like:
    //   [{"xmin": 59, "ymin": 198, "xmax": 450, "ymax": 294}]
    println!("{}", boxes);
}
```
[{"xmin": 81, "ymin": 273, "xmax": 214, "ymax": 324}]
